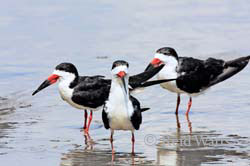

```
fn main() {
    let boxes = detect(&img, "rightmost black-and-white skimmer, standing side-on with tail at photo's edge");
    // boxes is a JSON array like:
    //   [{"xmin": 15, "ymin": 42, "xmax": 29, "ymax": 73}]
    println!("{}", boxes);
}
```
[{"xmin": 146, "ymin": 47, "xmax": 250, "ymax": 115}]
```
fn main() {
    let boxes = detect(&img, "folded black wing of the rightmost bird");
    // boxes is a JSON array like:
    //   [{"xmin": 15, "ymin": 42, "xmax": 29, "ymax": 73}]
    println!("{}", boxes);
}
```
[{"xmin": 176, "ymin": 56, "xmax": 250, "ymax": 93}]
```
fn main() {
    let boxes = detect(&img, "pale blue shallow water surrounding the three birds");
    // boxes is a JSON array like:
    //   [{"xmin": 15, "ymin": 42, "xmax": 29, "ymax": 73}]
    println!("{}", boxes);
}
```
[{"xmin": 0, "ymin": 0, "xmax": 250, "ymax": 166}]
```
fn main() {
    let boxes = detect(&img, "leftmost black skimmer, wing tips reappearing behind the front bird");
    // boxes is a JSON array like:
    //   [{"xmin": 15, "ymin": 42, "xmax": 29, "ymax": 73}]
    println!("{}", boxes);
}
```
[{"xmin": 32, "ymin": 63, "xmax": 168, "ymax": 132}]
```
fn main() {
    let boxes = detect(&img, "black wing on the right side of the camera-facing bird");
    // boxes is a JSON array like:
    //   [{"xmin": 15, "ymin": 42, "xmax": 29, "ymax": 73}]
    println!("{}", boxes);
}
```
[{"xmin": 130, "ymin": 95, "xmax": 149, "ymax": 130}]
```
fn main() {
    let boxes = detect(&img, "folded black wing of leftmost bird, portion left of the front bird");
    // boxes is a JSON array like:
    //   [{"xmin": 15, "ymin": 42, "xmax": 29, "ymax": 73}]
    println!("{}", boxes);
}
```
[{"xmin": 72, "ymin": 76, "xmax": 111, "ymax": 108}]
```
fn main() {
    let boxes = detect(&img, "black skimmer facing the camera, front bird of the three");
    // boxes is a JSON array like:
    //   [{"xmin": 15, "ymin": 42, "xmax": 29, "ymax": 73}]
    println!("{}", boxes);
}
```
[{"xmin": 102, "ymin": 60, "xmax": 175, "ymax": 154}]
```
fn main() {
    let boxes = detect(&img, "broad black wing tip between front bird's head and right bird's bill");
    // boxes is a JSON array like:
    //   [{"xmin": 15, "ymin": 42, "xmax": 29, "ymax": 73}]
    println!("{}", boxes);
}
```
[{"xmin": 129, "ymin": 65, "xmax": 164, "ymax": 88}]
